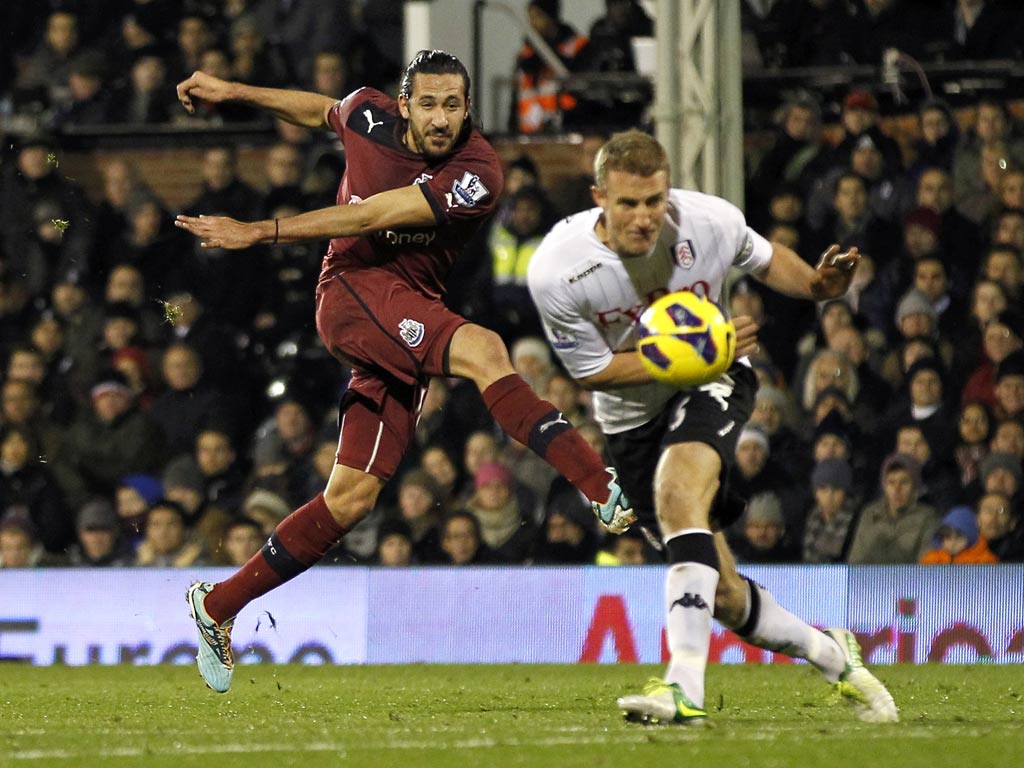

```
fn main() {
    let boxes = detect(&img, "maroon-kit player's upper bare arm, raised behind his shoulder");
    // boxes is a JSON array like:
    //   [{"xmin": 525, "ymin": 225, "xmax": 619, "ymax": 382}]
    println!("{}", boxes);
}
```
[{"xmin": 177, "ymin": 72, "xmax": 336, "ymax": 128}]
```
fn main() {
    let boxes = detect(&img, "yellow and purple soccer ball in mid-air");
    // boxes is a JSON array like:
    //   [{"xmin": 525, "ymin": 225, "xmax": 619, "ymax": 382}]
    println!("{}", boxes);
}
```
[{"xmin": 637, "ymin": 291, "xmax": 736, "ymax": 387}]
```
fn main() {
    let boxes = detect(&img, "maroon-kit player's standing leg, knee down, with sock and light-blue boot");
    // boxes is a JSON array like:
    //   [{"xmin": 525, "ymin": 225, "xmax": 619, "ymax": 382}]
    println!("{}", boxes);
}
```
[{"xmin": 185, "ymin": 466, "xmax": 384, "ymax": 693}]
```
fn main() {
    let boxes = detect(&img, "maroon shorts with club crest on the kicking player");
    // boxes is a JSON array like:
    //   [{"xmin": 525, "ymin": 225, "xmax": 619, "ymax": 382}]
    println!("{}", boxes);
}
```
[{"xmin": 316, "ymin": 269, "xmax": 466, "ymax": 480}]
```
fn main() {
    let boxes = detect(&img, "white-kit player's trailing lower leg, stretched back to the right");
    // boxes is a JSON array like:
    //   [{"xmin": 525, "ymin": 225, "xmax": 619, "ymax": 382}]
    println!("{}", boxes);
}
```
[{"xmin": 715, "ymin": 534, "xmax": 899, "ymax": 723}]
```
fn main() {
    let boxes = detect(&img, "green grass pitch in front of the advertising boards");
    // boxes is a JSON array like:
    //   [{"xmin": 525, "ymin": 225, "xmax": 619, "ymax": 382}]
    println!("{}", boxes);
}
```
[{"xmin": 0, "ymin": 666, "xmax": 1024, "ymax": 768}]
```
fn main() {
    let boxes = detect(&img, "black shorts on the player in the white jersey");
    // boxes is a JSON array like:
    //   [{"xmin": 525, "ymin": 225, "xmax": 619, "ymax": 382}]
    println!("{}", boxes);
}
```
[{"xmin": 607, "ymin": 364, "xmax": 758, "ymax": 532}]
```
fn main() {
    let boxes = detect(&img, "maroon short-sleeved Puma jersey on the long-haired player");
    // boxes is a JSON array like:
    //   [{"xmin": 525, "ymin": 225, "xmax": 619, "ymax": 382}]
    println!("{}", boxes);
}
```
[{"xmin": 321, "ymin": 88, "xmax": 503, "ymax": 298}]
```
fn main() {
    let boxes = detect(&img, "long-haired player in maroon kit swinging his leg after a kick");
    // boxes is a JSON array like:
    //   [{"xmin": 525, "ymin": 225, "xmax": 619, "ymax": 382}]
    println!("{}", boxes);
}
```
[{"xmin": 176, "ymin": 50, "xmax": 634, "ymax": 692}]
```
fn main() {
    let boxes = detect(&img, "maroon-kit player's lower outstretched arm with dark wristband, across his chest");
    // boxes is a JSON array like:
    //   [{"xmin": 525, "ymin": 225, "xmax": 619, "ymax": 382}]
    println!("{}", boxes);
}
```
[{"xmin": 174, "ymin": 185, "xmax": 436, "ymax": 250}]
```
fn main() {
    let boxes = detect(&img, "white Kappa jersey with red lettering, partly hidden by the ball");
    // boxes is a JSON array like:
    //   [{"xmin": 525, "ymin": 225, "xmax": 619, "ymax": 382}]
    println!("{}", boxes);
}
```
[{"xmin": 526, "ymin": 189, "xmax": 772, "ymax": 434}]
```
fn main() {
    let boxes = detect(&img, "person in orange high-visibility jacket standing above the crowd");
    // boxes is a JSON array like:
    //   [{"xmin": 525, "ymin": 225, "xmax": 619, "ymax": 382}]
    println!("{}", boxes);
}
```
[{"xmin": 509, "ymin": 0, "xmax": 588, "ymax": 133}]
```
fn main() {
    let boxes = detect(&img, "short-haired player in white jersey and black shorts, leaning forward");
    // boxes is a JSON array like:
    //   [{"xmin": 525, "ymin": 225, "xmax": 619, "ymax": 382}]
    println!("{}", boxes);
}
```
[{"xmin": 527, "ymin": 131, "xmax": 898, "ymax": 725}]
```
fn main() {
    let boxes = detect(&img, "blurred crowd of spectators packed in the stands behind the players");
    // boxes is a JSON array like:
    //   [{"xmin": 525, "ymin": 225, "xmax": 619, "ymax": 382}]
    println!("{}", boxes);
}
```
[{"xmin": 0, "ymin": 0, "xmax": 1024, "ymax": 567}]
